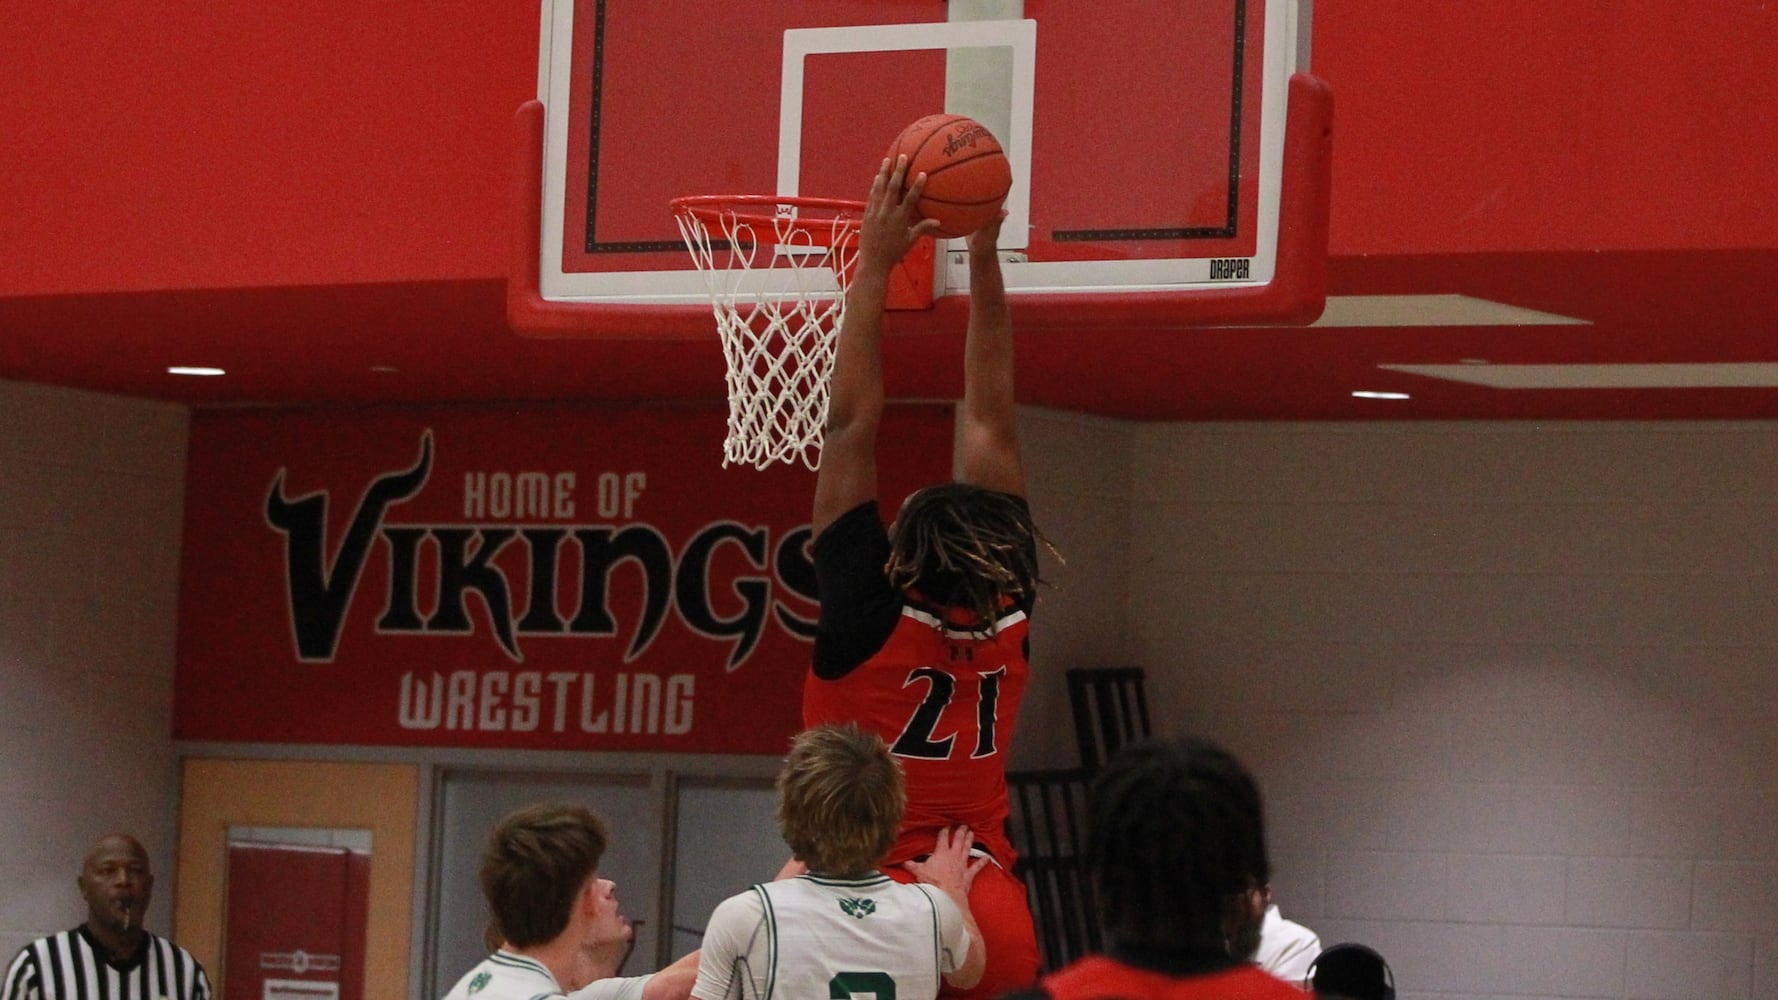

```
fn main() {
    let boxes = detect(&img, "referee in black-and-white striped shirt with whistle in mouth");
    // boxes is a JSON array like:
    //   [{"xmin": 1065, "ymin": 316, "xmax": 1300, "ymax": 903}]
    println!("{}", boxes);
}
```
[{"xmin": 0, "ymin": 833, "xmax": 210, "ymax": 1000}]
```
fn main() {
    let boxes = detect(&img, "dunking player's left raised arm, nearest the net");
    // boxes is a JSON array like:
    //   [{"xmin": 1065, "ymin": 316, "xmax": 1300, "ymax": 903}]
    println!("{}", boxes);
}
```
[{"xmin": 811, "ymin": 157, "xmax": 939, "ymax": 537}]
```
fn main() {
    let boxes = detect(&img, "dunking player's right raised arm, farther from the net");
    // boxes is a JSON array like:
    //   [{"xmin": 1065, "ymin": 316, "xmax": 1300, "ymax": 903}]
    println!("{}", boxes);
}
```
[{"xmin": 960, "ymin": 212, "xmax": 1024, "ymax": 496}]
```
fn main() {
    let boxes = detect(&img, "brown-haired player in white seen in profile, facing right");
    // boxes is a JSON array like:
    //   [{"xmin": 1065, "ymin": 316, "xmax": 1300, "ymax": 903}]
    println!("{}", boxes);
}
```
[{"xmin": 446, "ymin": 802, "xmax": 697, "ymax": 1000}]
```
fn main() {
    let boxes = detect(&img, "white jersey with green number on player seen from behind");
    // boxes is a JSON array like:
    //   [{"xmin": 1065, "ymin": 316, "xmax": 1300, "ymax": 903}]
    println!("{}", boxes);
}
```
[{"xmin": 692, "ymin": 874, "xmax": 969, "ymax": 1000}]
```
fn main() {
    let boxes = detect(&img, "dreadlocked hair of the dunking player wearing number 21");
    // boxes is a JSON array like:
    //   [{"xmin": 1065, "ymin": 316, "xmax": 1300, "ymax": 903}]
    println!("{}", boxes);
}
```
[{"xmin": 884, "ymin": 482, "xmax": 1056, "ymax": 630}]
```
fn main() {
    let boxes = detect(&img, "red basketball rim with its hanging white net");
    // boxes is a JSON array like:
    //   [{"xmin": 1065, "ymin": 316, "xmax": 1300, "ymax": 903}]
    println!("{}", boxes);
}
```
[{"xmin": 674, "ymin": 196, "xmax": 862, "ymax": 470}]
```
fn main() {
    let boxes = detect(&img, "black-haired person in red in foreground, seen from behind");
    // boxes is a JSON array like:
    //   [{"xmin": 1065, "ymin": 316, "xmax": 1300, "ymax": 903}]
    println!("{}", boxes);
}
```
[{"xmin": 1017, "ymin": 740, "xmax": 1303, "ymax": 1000}]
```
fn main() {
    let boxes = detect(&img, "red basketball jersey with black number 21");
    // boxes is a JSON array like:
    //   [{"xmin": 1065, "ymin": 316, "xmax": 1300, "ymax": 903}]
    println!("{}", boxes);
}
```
[{"xmin": 802, "ymin": 605, "xmax": 1031, "ymax": 870}]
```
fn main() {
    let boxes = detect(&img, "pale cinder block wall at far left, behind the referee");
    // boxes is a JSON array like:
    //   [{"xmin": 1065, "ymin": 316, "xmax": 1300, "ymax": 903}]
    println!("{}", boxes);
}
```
[{"xmin": 0, "ymin": 383, "xmax": 187, "ymax": 961}]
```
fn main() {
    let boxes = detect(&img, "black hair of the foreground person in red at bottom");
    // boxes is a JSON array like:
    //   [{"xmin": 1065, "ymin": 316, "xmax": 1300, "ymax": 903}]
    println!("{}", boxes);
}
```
[{"xmin": 1085, "ymin": 738, "xmax": 1271, "ymax": 947}]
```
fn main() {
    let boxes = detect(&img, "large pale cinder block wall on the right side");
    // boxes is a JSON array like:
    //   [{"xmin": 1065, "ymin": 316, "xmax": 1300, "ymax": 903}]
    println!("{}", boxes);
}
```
[{"xmin": 1123, "ymin": 422, "xmax": 1778, "ymax": 1000}]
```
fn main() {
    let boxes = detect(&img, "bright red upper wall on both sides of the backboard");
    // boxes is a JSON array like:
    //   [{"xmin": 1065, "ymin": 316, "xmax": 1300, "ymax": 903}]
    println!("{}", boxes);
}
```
[{"xmin": 0, "ymin": 0, "xmax": 1778, "ymax": 297}]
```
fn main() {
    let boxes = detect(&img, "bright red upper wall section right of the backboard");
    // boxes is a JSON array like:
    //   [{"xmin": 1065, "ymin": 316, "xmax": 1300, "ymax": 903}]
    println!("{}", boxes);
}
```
[{"xmin": 1314, "ymin": 0, "xmax": 1778, "ymax": 254}]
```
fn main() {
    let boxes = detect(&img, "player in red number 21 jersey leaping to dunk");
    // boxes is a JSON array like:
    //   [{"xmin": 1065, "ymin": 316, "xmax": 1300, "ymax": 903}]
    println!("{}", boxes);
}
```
[{"xmin": 804, "ymin": 149, "xmax": 1038, "ymax": 996}]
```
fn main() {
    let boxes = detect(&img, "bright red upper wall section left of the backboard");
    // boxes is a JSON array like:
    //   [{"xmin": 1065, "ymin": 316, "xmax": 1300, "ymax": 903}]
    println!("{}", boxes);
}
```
[{"xmin": 0, "ymin": 0, "xmax": 537, "ymax": 295}]
